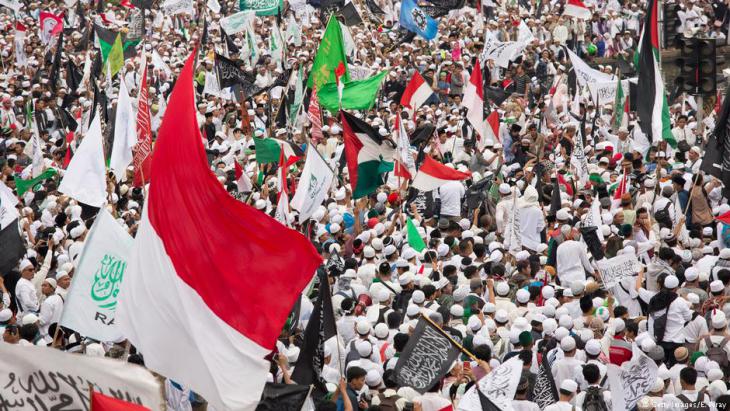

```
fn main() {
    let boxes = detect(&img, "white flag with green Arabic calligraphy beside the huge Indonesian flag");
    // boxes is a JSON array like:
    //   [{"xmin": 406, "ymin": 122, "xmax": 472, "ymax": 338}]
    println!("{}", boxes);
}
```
[{"xmin": 61, "ymin": 211, "xmax": 134, "ymax": 342}]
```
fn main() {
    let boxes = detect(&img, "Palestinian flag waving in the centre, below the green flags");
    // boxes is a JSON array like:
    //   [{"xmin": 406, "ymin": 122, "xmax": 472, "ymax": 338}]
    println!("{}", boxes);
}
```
[{"xmin": 340, "ymin": 110, "xmax": 395, "ymax": 199}]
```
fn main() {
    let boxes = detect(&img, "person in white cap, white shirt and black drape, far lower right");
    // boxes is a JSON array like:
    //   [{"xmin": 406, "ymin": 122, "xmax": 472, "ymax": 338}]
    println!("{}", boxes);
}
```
[{"xmin": 647, "ymin": 275, "xmax": 692, "ymax": 366}]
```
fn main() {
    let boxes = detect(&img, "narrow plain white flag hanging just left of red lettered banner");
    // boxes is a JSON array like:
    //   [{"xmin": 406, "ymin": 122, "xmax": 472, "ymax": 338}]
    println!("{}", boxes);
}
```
[{"xmin": 109, "ymin": 81, "xmax": 137, "ymax": 182}]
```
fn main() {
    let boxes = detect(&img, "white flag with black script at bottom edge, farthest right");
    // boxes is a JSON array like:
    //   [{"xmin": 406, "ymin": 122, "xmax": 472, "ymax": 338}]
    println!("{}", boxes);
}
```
[{"xmin": 606, "ymin": 345, "xmax": 659, "ymax": 411}]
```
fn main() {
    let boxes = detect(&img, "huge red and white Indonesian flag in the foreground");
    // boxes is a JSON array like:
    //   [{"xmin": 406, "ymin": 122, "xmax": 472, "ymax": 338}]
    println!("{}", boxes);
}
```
[{"xmin": 116, "ymin": 50, "xmax": 322, "ymax": 411}]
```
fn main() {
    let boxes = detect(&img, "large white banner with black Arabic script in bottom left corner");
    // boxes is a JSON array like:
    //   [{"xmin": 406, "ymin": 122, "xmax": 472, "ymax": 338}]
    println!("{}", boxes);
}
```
[{"xmin": 0, "ymin": 344, "xmax": 164, "ymax": 411}]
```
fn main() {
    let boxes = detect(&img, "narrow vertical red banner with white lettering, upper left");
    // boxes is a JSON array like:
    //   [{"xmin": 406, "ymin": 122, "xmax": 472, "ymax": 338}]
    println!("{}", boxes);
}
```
[{"xmin": 132, "ymin": 65, "xmax": 152, "ymax": 187}]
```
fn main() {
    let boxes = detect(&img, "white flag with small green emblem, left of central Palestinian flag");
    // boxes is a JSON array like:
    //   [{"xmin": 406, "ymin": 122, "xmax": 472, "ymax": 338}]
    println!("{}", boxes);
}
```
[{"xmin": 291, "ymin": 144, "xmax": 335, "ymax": 223}]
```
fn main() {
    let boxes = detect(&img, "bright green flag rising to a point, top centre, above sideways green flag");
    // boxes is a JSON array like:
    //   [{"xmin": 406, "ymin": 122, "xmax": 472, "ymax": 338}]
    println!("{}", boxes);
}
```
[{"xmin": 307, "ymin": 15, "xmax": 350, "ymax": 94}]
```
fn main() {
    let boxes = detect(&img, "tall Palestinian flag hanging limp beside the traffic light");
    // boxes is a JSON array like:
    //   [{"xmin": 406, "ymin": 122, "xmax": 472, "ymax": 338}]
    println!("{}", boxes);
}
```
[{"xmin": 636, "ymin": 0, "xmax": 677, "ymax": 148}]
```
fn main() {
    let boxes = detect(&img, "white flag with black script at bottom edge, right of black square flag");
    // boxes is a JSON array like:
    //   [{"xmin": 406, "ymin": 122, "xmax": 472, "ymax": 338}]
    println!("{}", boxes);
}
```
[{"xmin": 458, "ymin": 357, "xmax": 524, "ymax": 411}]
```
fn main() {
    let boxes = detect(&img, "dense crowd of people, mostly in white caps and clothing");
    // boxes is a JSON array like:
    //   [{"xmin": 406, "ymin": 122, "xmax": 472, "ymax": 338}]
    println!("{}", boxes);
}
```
[{"xmin": 0, "ymin": 0, "xmax": 730, "ymax": 411}]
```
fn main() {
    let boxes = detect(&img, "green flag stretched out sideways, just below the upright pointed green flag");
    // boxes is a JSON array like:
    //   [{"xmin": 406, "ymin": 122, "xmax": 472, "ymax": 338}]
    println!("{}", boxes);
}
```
[{"xmin": 318, "ymin": 70, "xmax": 388, "ymax": 113}]
